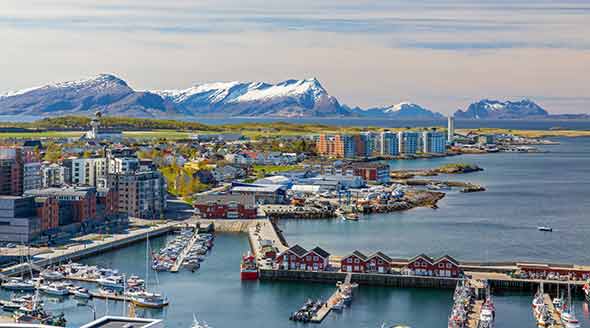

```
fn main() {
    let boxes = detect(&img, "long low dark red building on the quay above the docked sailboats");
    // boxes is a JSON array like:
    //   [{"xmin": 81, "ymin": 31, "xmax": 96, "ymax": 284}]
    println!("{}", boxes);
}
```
[{"xmin": 193, "ymin": 194, "xmax": 258, "ymax": 219}]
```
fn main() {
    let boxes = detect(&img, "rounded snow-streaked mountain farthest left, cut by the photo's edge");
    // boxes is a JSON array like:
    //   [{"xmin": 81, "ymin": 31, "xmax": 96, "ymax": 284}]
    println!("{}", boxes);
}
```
[{"xmin": 0, "ymin": 74, "xmax": 177, "ymax": 117}]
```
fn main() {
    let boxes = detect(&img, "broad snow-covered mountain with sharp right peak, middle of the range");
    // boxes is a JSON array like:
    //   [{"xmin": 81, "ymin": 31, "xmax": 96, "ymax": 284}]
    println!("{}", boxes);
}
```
[{"xmin": 154, "ymin": 78, "xmax": 351, "ymax": 117}]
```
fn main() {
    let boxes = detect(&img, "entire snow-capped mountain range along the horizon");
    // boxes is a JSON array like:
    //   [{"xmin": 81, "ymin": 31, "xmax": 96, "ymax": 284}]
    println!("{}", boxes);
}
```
[{"xmin": 0, "ymin": 74, "xmax": 588, "ymax": 120}]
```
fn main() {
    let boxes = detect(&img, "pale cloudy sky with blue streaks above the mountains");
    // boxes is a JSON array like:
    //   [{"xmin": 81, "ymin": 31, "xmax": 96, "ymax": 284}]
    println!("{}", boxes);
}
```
[{"xmin": 0, "ymin": 0, "xmax": 590, "ymax": 113}]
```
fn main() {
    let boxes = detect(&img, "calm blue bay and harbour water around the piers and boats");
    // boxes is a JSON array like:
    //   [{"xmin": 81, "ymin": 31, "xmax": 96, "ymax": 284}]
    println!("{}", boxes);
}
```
[{"xmin": 0, "ymin": 138, "xmax": 590, "ymax": 328}]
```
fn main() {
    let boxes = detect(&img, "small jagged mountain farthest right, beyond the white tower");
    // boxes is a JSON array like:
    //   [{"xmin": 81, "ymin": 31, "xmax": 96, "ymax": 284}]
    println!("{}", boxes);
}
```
[{"xmin": 455, "ymin": 99, "xmax": 549, "ymax": 119}]
